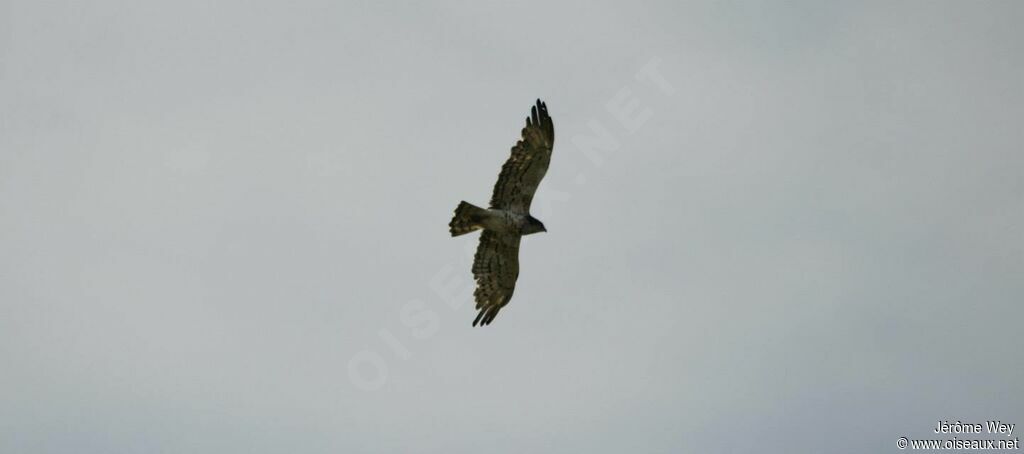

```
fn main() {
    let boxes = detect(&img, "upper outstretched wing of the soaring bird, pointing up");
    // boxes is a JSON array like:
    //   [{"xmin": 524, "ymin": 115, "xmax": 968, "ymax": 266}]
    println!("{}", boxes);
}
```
[{"xmin": 490, "ymin": 99, "xmax": 555, "ymax": 213}]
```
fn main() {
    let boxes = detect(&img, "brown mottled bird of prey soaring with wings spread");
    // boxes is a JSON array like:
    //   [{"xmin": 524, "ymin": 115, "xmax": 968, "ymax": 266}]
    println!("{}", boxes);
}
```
[{"xmin": 449, "ymin": 99, "xmax": 555, "ymax": 326}]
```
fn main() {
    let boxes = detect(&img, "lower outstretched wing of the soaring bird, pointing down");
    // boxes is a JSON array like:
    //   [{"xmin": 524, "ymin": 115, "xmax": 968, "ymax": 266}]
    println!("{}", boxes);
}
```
[{"xmin": 473, "ymin": 230, "xmax": 522, "ymax": 326}]
